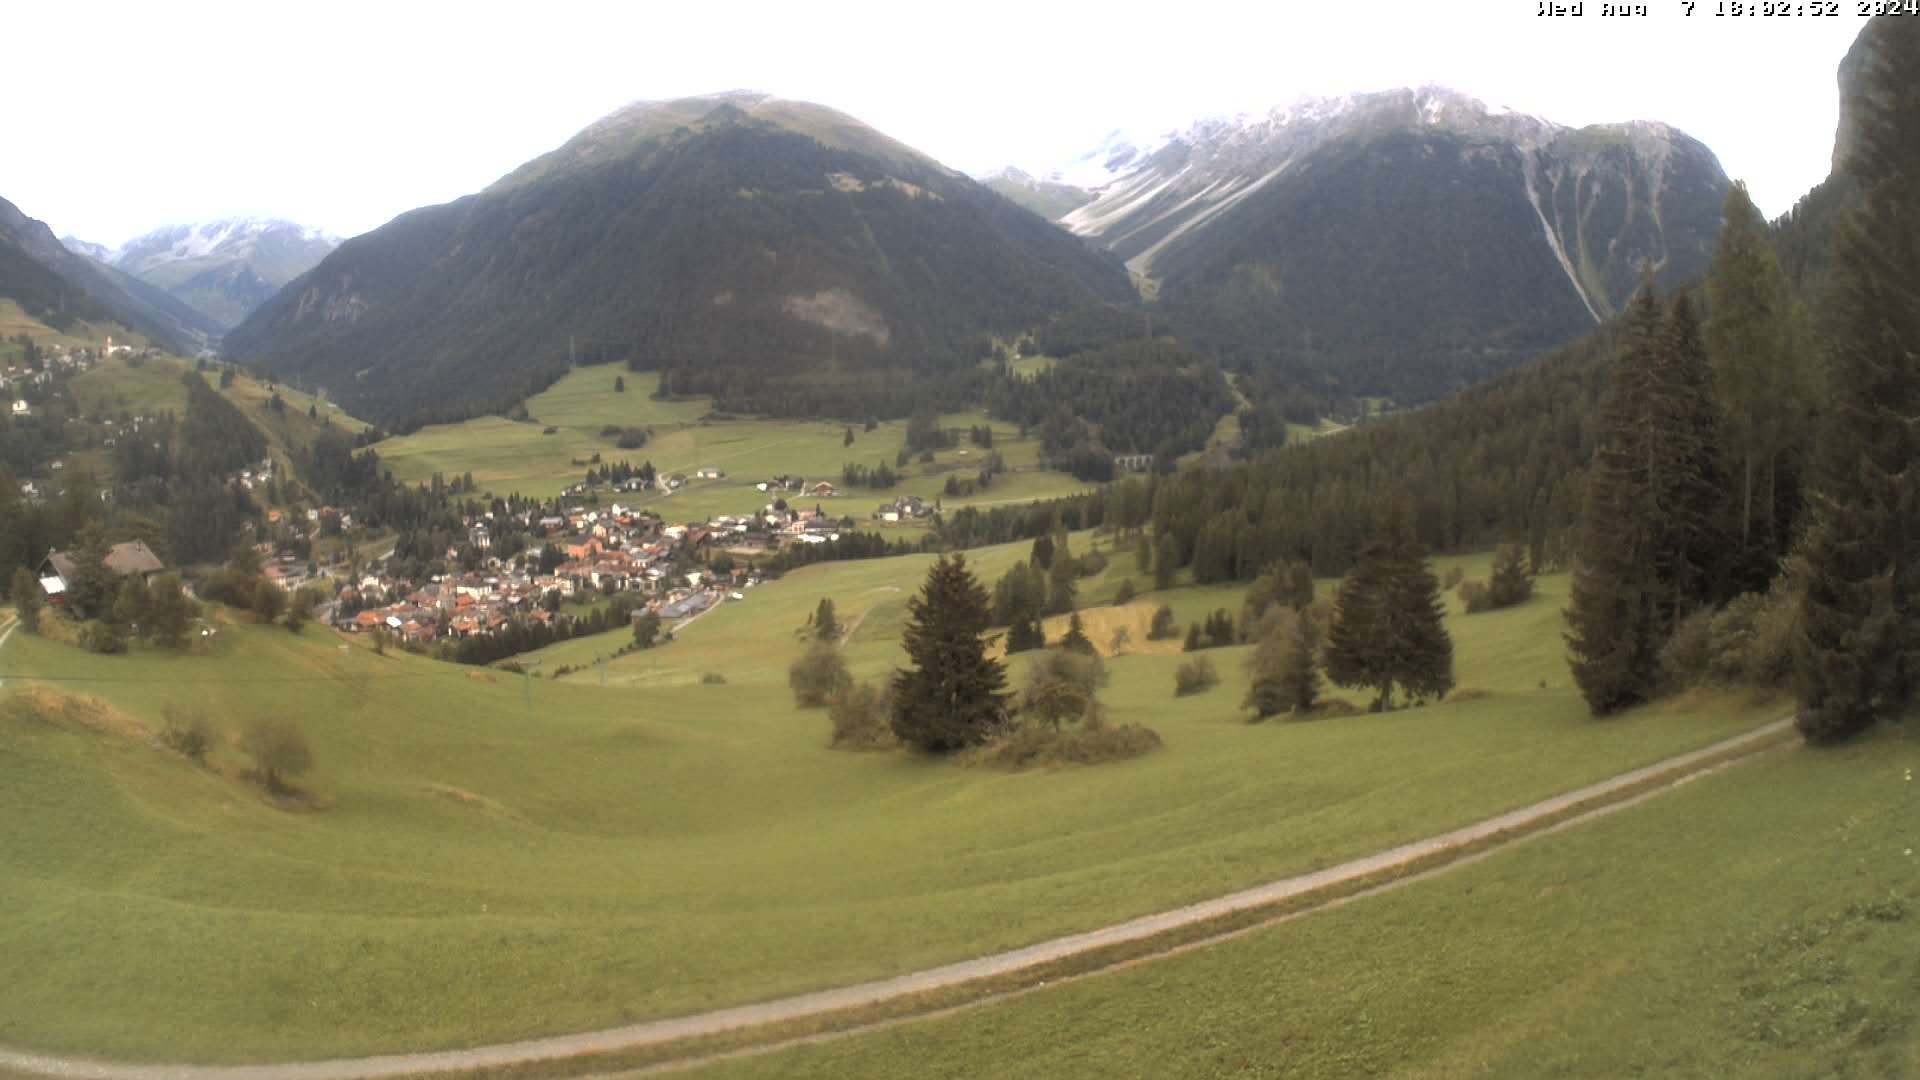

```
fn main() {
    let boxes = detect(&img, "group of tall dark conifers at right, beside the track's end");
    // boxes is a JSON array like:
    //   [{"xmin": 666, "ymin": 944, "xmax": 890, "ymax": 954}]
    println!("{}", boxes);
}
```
[{"xmin": 1567, "ymin": 19, "xmax": 1920, "ymax": 740}]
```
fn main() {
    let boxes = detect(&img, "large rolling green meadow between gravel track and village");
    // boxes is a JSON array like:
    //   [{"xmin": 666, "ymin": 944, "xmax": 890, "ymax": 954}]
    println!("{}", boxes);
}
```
[{"xmin": 0, "ymin": 536, "xmax": 1778, "ymax": 1063}]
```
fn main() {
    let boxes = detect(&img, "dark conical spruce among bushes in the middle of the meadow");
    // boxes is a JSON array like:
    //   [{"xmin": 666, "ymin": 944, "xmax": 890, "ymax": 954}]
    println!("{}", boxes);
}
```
[{"xmin": 891, "ymin": 555, "xmax": 1010, "ymax": 753}]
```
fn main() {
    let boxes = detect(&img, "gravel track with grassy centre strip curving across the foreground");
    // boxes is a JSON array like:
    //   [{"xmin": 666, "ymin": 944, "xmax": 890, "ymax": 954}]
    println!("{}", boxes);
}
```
[{"xmin": 0, "ymin": 717, "xmax": 1793, "ymax": 1080}]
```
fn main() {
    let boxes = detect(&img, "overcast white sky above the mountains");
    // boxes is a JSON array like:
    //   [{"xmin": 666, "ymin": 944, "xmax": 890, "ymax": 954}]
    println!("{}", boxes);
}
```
[{"xmin": 0, "ymin": 0, "xmax": 1860, "ymax": 244}]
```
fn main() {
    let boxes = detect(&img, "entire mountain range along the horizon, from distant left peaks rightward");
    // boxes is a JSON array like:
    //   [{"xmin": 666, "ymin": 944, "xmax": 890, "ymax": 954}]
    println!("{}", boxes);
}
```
[{"xmin": 7, "ymin": 86, "xmax": 1728, "ymax": 423}]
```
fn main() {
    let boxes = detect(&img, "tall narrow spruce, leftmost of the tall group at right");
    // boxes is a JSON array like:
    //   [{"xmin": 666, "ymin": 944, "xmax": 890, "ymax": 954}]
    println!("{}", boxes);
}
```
[{"xmin": 1567, "ymin": 284, "xmax": 1663, "ymax": 715}]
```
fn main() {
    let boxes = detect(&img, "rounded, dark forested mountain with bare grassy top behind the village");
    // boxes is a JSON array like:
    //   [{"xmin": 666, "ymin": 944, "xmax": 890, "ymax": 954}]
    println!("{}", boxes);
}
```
[{"xmin": 227, "ymin": 92, "xmax": 1131, "ymax": 419}]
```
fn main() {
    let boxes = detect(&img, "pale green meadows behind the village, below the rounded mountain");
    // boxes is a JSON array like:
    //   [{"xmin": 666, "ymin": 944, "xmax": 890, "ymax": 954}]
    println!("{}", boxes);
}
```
[{"xmin": 376, "ymin": 367, "xmax": 1089, "ymax": 521}]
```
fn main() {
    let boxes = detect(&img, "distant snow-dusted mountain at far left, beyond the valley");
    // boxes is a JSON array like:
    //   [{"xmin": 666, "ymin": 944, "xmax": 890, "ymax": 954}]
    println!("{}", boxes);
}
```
[{"xmin": 60, "ymin": 217, "xmax": 340, "ymax": 332}]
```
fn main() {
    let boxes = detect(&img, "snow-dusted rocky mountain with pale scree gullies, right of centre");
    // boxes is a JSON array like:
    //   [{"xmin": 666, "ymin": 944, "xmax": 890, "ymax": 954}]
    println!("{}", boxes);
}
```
[{"xmin": 987, "ymin": 86, "xmax": 1730, "ymax": 396}]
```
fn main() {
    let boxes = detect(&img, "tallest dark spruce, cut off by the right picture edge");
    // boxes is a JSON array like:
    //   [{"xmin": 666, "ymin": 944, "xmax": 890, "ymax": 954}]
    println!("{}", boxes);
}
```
[{"xmin": 1793, "ymin": 19, "xmax": 1920, "ymax": 740}]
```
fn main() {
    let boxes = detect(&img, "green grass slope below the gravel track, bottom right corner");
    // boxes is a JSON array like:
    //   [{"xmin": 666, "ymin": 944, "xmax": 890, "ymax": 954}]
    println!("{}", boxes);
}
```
[{"xmin": 697, "ymin": 723, "xmax": 1920, "ymax": 1080}]
